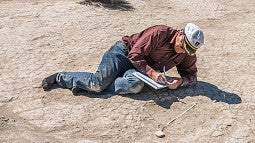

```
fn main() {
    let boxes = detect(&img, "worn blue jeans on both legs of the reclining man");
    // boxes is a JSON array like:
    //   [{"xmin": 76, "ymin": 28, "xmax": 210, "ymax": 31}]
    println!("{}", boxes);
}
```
[{"xmin": 56, "ymin": 41, "xmax": 144, "ymax": 94}]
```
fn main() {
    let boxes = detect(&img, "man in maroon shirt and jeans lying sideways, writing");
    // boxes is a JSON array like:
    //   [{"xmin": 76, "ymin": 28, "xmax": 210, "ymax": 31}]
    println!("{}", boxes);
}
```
[{"xmin": 42, "ymin": 23, "xmax": 204, "ymax": 94}]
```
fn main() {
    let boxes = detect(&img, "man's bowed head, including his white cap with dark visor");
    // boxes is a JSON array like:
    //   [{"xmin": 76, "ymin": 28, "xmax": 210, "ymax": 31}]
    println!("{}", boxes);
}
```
[{"xmin": 175, "ymin": 23, "xmax": 204, "ymax": 56}]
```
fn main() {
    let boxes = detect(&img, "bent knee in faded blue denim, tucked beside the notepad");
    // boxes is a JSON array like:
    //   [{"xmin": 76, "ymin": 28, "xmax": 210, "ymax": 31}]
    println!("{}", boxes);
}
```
[{"xmin": 107, "ymin": 69, "xmax": 144, "ymax": 94}]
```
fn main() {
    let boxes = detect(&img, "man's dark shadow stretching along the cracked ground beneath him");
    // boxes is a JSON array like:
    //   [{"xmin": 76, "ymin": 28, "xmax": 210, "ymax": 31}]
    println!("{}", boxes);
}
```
[{"xmin": 76, "ymin": 81, "xmax": 242, "ymax": 109}]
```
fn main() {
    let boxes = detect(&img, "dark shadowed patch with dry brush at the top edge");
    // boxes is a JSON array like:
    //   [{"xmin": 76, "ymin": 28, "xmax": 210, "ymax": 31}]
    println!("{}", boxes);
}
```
[{"xmin": 77, "ymin": 0, "xmax": 134, "ymax": 11}]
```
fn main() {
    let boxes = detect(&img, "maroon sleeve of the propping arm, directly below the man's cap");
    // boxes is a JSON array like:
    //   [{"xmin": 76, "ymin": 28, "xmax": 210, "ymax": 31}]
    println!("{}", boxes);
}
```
[{"xmin": 176, "ymin": 55, "xmax": 197, "ymax": 87}]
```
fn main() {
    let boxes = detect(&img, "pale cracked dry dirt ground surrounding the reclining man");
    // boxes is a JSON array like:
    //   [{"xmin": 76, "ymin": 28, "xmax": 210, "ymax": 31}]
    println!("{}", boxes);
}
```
[{"xmin": 0, "ymin": 0, "xmax": 255, "ymax": 143}]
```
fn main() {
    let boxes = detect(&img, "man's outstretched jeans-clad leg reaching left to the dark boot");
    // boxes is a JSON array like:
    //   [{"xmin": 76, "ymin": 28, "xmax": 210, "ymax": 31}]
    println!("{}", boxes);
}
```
[{"xmin": 45, "ymin": 42, "xmax": 133, "ymax": 92}]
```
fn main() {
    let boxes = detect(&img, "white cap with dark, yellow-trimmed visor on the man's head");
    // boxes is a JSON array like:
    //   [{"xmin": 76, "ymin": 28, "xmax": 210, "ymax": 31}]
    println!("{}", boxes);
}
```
[{"xmin": 183, "ymin": 23, "xmax": 204, "ymax": 56}]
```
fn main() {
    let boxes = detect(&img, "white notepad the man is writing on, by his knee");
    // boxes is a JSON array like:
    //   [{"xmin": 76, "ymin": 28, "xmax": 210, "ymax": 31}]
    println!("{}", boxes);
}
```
[{"xmin": 133, "ymin": 72, "xmax": 167, "ymax": 89}]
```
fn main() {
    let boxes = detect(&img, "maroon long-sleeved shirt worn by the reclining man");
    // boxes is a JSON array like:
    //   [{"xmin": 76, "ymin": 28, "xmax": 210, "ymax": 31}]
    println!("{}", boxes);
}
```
[{"xmin": 122, "ymin": 25, "xmax": 197, "ymax": 86}]
